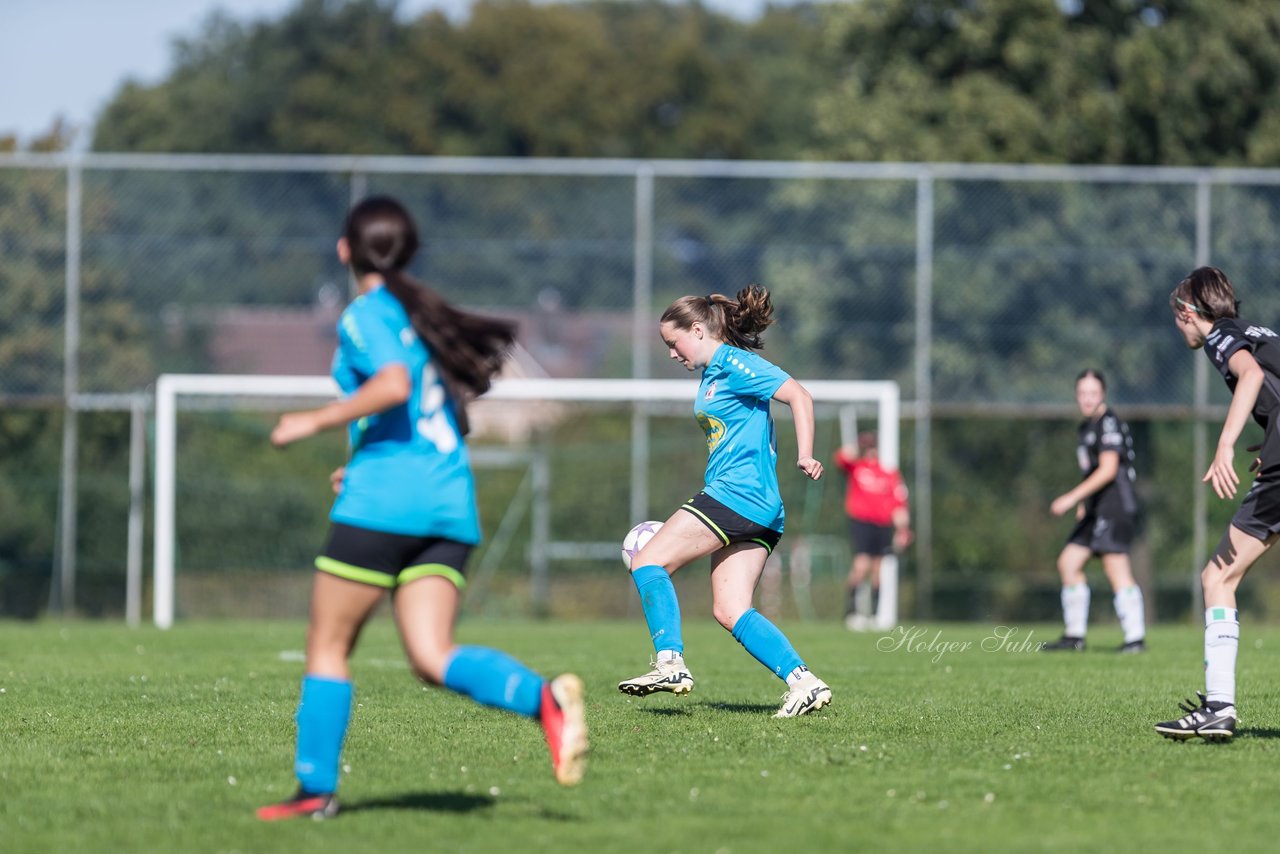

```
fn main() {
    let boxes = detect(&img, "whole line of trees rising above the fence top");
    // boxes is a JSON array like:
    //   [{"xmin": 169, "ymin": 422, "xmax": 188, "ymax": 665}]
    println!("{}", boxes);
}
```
[{"xmin": 0, "ymin": 0, "xmax": 1280, "ymax": 166}]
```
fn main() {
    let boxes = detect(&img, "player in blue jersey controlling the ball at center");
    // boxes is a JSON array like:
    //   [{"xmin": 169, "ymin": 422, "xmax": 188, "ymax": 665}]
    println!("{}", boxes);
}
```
[{"xmin": 618, "ymin": 284, "xmax": 831, "ymax": 717}]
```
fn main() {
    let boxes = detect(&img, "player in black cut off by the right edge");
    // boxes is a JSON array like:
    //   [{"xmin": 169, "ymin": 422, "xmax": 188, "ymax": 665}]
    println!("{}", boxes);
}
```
[{"xmin": 1156, "ymin": 266, "xmax": 1280, "ymax": 740}]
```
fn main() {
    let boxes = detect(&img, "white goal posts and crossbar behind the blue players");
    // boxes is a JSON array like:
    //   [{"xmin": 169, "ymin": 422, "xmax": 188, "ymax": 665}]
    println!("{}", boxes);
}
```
[{"xmin": 152, "ymin": 374, "xmax": 901, "ymax": 629}]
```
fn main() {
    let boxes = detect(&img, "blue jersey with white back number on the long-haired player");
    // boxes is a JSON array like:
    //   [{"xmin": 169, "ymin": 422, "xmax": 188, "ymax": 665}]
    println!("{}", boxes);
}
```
[{"xmin": 329, "ymin": 287, "xmax": 480, "ymax": 544}]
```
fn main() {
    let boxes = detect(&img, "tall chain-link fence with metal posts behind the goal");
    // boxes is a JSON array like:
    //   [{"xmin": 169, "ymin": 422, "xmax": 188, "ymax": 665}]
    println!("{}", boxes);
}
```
[{"xmin": 0, "ymin": 154, "xmax": 1280, "ymax": 617}]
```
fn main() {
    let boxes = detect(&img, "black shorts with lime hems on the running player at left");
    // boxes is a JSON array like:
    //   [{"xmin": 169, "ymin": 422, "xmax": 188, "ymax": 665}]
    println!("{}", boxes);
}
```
[{"xmin": 316, "ymin": 522, "xmax": 471, "ymax": 590}]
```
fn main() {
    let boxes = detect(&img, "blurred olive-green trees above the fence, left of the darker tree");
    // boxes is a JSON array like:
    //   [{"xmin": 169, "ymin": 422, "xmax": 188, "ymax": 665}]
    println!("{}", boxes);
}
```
[{"xmin": 93, "ymin": 0, "xmax": 827, "ymax": 159}]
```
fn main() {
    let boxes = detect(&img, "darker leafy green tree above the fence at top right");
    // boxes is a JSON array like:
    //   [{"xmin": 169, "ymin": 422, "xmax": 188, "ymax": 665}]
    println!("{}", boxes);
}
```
[{"xmin": 814, "ymin": 0, "xmax": 1280, "ymax": 166}]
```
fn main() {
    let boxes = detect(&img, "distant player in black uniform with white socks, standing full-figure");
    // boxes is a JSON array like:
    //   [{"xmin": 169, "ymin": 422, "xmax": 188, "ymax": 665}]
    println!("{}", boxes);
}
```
[{"xmin": 1043, "ymin": 370, "xmax": 1147, "ymax": 653}]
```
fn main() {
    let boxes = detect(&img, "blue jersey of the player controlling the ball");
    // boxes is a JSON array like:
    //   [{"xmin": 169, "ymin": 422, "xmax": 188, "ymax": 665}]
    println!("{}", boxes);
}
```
[{"xmin": 694, "ymin": 344, "xmax": 791, "ymax": 533}]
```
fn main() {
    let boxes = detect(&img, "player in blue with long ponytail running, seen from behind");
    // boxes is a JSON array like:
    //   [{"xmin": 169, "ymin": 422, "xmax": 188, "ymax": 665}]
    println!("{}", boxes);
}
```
[{"xmin": 257, "ymin": 197, "xmax": 586, "ymax": 821}]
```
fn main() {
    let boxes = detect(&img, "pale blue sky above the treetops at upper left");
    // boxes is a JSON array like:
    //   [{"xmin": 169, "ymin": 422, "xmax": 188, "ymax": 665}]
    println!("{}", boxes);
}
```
[{"xmin": 0, "ymin": 0, "xmax": 764, "ymax": 142}]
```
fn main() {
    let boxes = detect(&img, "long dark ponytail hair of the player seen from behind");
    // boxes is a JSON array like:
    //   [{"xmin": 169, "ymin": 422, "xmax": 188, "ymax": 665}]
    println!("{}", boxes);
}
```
[{"xmin": 342, "ymin": 196, "xmax": 516, "ymax": 435}]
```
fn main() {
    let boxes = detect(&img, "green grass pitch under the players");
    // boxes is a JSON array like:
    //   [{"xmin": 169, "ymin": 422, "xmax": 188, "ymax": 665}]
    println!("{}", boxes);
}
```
[{"xmin": 0, "ymin": 617, "xmax": 1280, "ymax": 854}]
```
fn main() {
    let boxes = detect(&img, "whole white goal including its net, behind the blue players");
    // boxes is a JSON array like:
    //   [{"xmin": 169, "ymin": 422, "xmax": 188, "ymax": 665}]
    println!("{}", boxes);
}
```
[{"xmin": 152, "ymin": 374, "xmax": 900, "ymax": 627}]
